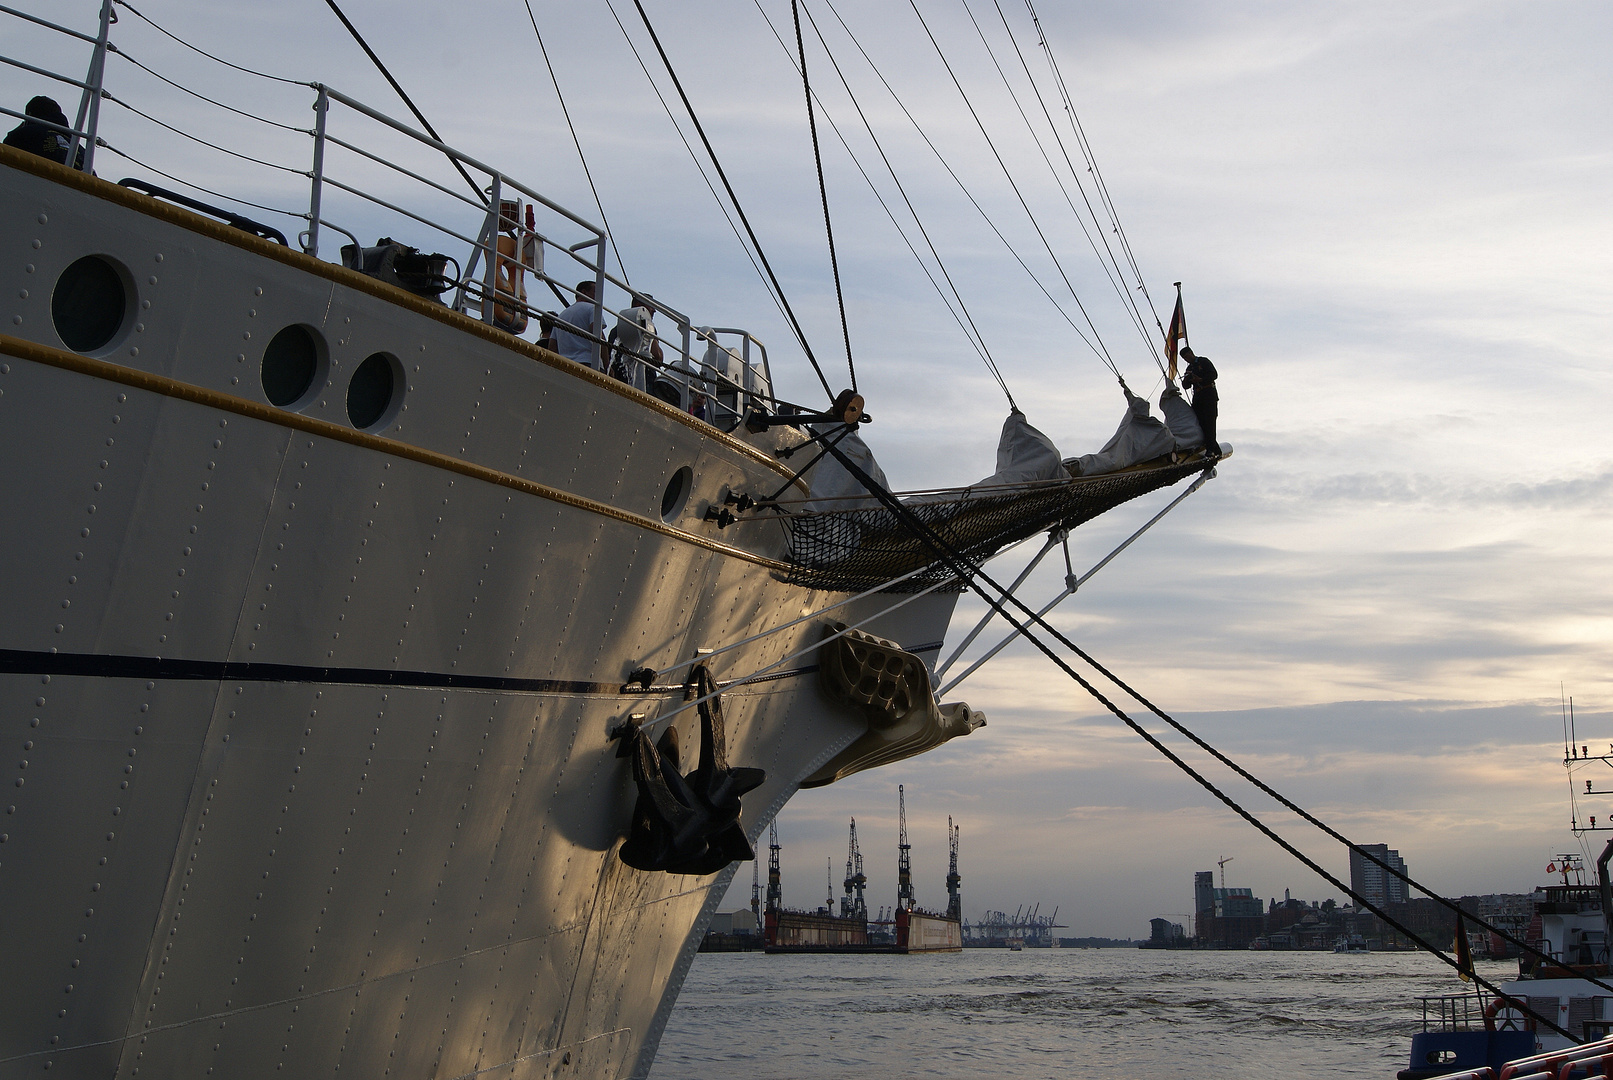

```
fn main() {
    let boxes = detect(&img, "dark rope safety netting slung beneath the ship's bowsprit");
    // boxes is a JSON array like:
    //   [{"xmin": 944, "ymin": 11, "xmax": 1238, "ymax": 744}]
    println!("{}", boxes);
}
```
[{"xmin": 779, "ymin": 458, "xmax": 1210, "ymax": 593}]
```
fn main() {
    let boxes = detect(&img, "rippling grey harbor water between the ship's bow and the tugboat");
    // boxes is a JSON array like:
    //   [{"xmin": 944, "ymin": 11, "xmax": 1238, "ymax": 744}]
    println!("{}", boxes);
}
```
[{"xmin": 650, "ymin": 949, "xmax": 1518, "ymax": 1080}]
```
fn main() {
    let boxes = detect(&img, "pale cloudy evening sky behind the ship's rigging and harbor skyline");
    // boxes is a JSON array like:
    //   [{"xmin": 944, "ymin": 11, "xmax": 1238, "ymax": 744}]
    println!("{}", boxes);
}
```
[{"xmin": 15, "ymin": 0, "xmax": 1613, "ymax": 937}]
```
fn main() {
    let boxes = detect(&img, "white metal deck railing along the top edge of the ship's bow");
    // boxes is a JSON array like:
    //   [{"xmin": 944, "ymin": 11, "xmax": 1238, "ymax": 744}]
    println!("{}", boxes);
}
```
[{"xmin": 0, "ymin": 0, "xmax": 776, "ymax": 430}]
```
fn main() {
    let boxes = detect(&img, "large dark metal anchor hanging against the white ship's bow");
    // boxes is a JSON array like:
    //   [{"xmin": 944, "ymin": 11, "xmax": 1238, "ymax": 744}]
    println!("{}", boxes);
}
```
[{"xmin": 613, "ymin": 664, "xmax": 766, "ymax": 875}]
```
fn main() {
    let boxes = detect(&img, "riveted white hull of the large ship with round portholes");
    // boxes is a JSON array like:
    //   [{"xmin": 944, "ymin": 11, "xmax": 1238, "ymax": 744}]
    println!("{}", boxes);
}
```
[{"xmin": 0, "ymin": 152, "xmax": 953, "ymax": 1078}]
